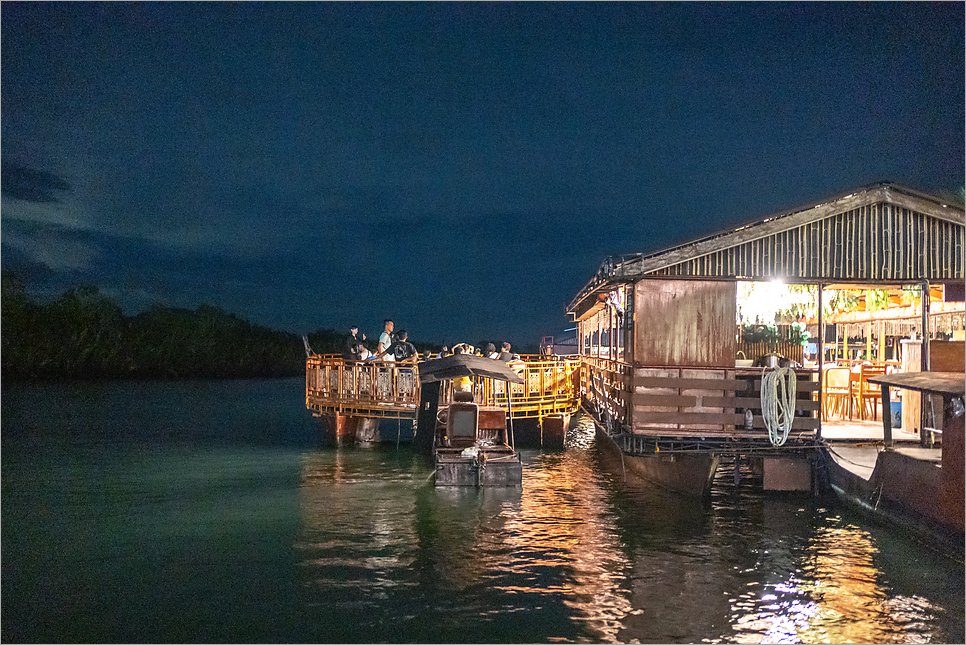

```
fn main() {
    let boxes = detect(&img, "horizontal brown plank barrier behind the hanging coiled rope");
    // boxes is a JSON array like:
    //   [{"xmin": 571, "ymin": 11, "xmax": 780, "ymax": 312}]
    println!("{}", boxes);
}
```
[{"xmin": 630, "ymin": 367, "xmax": 819, "ymax": 438}]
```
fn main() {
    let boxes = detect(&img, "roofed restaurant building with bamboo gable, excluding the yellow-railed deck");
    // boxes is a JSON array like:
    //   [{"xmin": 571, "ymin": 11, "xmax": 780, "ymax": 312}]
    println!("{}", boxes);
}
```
[{"xmin": 568, "ymin": 183, "xmax": 964, "ymax": 512}]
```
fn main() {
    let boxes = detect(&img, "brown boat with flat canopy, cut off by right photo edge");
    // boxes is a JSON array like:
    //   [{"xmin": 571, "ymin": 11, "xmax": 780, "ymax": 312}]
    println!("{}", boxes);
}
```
[{"xmin": 827, "ymin": 372, "xmax": 964, "ymax": 558}]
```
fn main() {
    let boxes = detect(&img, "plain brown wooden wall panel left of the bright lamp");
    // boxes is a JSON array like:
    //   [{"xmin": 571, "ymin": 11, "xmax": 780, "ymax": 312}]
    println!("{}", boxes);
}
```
[{"xmin": 634, "ymin": 279, "xmax": 737, "ymax": 369}]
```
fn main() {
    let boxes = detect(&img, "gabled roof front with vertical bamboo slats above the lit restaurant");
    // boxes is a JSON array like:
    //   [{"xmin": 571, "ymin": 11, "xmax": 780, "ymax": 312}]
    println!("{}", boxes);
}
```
[{"xmin": 568, "ymin": 182, "xmax": 966, "ymax": 320}]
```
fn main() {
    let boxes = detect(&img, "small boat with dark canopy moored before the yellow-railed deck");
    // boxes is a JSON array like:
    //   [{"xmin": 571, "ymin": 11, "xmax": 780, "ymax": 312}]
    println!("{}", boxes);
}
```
[{"xmin": 414, "ymin": 354, "xmax": 523, "ymax": 487}]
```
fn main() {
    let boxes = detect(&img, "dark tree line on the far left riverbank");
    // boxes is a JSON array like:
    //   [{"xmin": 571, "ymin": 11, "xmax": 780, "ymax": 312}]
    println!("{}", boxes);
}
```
[{"xmin": 0, "ymin": 273, "xmax": 343, "ymax": 380}]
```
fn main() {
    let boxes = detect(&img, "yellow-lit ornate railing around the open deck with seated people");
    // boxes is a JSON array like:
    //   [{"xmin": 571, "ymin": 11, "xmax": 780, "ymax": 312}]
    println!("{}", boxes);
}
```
[{"xmin": 305, "ymin": 354, "xmax": 581, "ymax": 419}]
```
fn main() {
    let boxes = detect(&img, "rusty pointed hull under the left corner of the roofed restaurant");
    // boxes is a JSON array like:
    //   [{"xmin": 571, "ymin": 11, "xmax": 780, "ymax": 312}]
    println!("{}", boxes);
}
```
[{"xmin": 597, "ymin": 426, "xmax": 720, "ymax": 497}]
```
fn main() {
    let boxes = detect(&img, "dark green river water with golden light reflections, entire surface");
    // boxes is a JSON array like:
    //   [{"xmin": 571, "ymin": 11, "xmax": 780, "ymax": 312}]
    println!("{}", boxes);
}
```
[{"xmin": 0, "ymin": 379, "xmax": 964, "ymax": 643}]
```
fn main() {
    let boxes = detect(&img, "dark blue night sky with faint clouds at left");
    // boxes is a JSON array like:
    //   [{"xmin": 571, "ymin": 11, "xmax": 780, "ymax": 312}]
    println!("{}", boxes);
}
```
[{"xmin": 0, "ymin": 1, "xmax": 966, "ymax": 344}]
